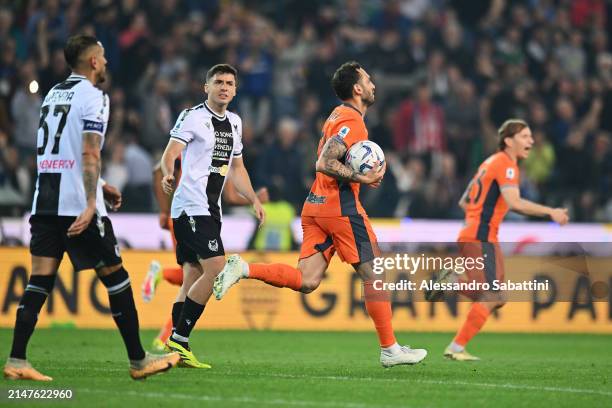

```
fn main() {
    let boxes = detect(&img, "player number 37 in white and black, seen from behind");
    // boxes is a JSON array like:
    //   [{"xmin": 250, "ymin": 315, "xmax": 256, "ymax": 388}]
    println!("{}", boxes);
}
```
[{"xmin": 4, "ymin": 35, "xmax": 179, "ymax": 381}]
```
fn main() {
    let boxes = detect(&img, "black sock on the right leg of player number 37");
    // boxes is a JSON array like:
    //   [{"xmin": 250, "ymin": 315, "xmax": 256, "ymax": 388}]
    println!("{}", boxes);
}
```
[{"xmin": 100, "ymin": 268, "xmax": 145, "ymax": 360}]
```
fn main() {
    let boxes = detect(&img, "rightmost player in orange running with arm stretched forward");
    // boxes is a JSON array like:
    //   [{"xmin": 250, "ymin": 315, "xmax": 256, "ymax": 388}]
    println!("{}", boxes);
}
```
[{"xmin": 427, "ymin": 119, "xmax": 569, "ymax": 361}]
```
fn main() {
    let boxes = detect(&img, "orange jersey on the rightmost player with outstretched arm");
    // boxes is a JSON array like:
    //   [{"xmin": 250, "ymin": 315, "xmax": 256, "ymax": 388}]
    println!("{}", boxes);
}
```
[{"xmin": 459, "ymin": 152, "xmax": 519, "ymax": 242}]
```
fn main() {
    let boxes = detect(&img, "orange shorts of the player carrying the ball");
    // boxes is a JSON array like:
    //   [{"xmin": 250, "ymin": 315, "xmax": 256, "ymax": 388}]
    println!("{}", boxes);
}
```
[{"xmin": 300, "ymin": 215, "xmax": 380, "ymax": 265}]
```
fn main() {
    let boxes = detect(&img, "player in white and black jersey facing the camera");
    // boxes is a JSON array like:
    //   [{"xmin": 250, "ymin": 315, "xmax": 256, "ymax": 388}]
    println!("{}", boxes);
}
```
[{"xmin": 161, "ymin": 64, "xmax": 265, "ymax": 368}]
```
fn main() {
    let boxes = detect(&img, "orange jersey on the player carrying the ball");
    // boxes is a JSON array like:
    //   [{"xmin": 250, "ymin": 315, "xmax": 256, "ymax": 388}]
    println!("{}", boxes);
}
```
[{"xmin": 302, "ymin": 104, "xmax": 368, "ymax": 217}]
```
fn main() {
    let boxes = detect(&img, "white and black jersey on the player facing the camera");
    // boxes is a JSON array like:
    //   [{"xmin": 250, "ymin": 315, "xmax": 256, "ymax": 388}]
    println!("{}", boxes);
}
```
[{"xmin": 170, "ymin": 102, "xmax": 242, "ymax": 220}]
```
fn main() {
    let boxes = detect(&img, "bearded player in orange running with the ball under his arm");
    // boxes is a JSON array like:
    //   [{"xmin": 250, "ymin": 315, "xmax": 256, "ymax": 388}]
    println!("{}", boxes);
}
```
[{"xmin": 213, "ymin": 62, "xmax": 427, "ymax": 367}]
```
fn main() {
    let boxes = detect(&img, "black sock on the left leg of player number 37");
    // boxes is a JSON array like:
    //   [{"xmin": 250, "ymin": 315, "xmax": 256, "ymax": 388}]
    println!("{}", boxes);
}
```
[{"xmin": 11, "ymin": 275, "xmax": 56, "ymax": 360}]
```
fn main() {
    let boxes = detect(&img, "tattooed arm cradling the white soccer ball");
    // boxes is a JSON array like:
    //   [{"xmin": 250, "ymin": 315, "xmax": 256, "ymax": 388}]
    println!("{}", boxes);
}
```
[{"xmin": 316, "ymin": 137, "xmax": 386, "ymax": 184}]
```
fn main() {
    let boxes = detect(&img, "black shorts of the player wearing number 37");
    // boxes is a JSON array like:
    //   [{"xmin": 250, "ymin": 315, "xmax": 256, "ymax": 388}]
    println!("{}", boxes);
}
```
[{"xmin": 30, "ymin": 215, "xmax": 122, "ymax": 271}]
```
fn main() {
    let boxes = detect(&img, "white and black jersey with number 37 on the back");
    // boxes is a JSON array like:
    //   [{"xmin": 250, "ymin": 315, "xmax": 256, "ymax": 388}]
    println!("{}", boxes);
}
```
[{"xmin": 32, "ymin": 74, "xmax": 110, "ymax": 216}]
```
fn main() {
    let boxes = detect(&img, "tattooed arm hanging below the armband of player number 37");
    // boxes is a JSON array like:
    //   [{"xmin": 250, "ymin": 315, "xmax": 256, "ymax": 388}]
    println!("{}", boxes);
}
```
[{"xmin": 67, "ymin": 132, "xmax": 102, "ymax": 237}]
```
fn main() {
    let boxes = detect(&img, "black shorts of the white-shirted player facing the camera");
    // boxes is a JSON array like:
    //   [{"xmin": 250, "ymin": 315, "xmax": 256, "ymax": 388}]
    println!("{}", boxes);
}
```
[{"xmin": 172, "ymin": 213, "xmax": 225, "ymax": 265}]
